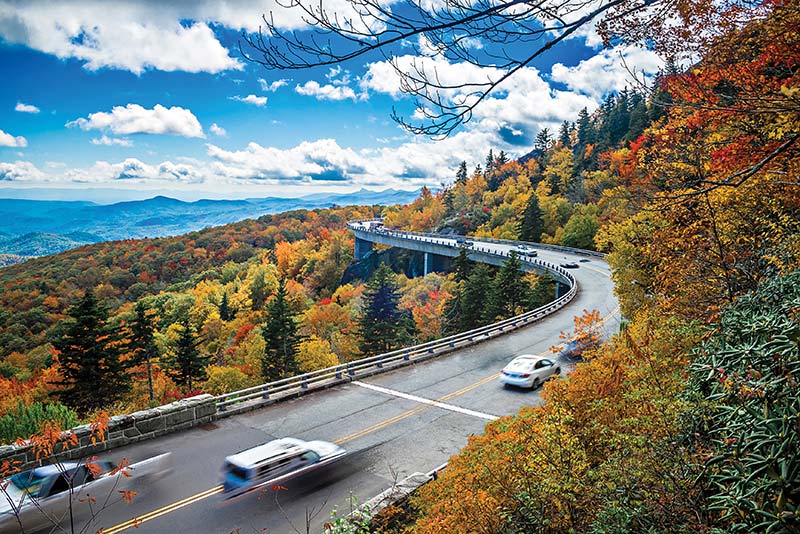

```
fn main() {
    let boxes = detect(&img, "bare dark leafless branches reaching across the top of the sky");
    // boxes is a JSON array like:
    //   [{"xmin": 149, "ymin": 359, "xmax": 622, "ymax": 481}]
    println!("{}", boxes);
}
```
[{"xmin": 239, "ymin": 0, "xmax": 671, "ymax": 138}]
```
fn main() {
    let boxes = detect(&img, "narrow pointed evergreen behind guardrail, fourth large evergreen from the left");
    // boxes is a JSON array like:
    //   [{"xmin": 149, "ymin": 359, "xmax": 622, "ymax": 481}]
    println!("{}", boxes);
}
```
[{"xmin": 261, "ymin": 278, "xmax": 300, "ymax": 382}]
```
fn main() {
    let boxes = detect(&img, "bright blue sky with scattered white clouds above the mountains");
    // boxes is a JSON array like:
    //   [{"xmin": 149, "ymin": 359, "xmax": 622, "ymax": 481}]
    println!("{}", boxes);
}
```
[{"xmin": 0, "ymin": 0, "xmax": 662, "ymax": 200}]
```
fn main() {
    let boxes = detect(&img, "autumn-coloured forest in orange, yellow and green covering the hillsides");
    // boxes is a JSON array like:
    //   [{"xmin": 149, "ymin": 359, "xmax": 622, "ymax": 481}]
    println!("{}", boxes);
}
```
[{"xmin": 0, "ymin": 2, "xmax": 800, "ymax": 534}]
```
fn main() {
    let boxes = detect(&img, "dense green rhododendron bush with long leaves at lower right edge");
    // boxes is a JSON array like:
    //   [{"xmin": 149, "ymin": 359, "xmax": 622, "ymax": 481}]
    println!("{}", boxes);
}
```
[{"xmin": 689, "ymin": 272, "xmax": 800, "ymax": 532}]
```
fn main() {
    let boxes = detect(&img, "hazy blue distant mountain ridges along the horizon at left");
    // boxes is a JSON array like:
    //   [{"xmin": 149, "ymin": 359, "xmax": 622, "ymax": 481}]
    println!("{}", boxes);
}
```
[{"xmin": 0, "ymin": 189, "xmax": 419, "ymax": 257}]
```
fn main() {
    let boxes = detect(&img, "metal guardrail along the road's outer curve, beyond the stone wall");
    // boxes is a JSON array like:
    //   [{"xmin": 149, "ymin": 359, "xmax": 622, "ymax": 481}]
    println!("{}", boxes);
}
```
[{"xmin": 216, "ymin": 224, "xmax": 578, "ymax": 414}]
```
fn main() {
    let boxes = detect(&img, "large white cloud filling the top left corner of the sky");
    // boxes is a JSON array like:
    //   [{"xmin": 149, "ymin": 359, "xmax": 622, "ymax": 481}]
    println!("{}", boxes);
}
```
[{"xmin": 0, "ymin": 0, "xmax": 244, "ymax": 74}]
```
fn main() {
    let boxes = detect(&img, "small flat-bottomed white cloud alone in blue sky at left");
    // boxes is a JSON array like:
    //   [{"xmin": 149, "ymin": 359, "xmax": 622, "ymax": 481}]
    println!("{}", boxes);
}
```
[{"xmin": 67, "ymin": 104, "xmax": 205, "ymax": 137}]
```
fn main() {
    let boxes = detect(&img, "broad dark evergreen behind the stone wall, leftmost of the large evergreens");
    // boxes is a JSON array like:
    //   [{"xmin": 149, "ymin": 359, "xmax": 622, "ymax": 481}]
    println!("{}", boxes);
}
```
[{"xmin": 53, "ymin": 289, "xmax": 130, "ymax": 415}]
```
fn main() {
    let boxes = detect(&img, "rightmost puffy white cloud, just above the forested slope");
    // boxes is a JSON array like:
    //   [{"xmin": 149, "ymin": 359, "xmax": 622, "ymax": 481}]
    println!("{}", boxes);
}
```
[{"xmin": 550, "ymin": 46, "xmax": 664, "ymax": 100}]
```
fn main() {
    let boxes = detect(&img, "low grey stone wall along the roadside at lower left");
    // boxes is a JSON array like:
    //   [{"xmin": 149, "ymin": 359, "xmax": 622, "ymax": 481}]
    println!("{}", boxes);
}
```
[{"xmin": 0, "ymin": 395, "xmax": 217, "ymax": 470}]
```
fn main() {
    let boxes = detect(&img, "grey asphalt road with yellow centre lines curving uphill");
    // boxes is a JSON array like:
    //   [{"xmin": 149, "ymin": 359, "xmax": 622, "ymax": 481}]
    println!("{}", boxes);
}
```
[{"xmin": 83, "ymin": 240, "xmax": 619, "ymax": 534}]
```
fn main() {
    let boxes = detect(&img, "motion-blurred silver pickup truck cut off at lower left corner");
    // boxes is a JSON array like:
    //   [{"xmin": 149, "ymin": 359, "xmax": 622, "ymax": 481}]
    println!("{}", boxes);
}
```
[{"xmin": 0, "ymin": 453, "xmax": 172, "ymax": 534}]
